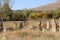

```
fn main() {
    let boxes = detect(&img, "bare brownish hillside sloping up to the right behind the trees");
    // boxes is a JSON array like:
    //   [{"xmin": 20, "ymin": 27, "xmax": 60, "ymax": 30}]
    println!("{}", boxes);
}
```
[{"xmin": 32, "ymin": 0, "xmax": 60, "ymax": 10}]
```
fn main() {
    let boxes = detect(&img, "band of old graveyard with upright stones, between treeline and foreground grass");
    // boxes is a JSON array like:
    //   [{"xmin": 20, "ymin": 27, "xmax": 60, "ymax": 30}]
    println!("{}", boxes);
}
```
[{"xmin": 0, "ymin": 18, "xmax": 60, "ymax": 32}]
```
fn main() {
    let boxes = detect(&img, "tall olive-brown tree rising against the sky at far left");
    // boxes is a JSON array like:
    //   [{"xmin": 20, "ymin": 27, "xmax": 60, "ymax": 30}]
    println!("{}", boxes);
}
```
[{"xmin": 2, "ymin": 0, "xmax": 12, "ymax": 20}]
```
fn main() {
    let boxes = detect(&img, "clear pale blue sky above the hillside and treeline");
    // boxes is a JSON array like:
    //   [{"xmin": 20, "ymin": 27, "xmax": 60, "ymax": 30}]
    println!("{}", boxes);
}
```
[{"xmin": 11, "ymin": 0, "xmax": 56, "ymax": 10}]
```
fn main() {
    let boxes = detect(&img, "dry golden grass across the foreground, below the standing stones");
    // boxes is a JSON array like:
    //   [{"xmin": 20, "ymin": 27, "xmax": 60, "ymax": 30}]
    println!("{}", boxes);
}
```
[{"xmin": 0, "ymin": 30, "xmax": 60, "ymax": 40}]
